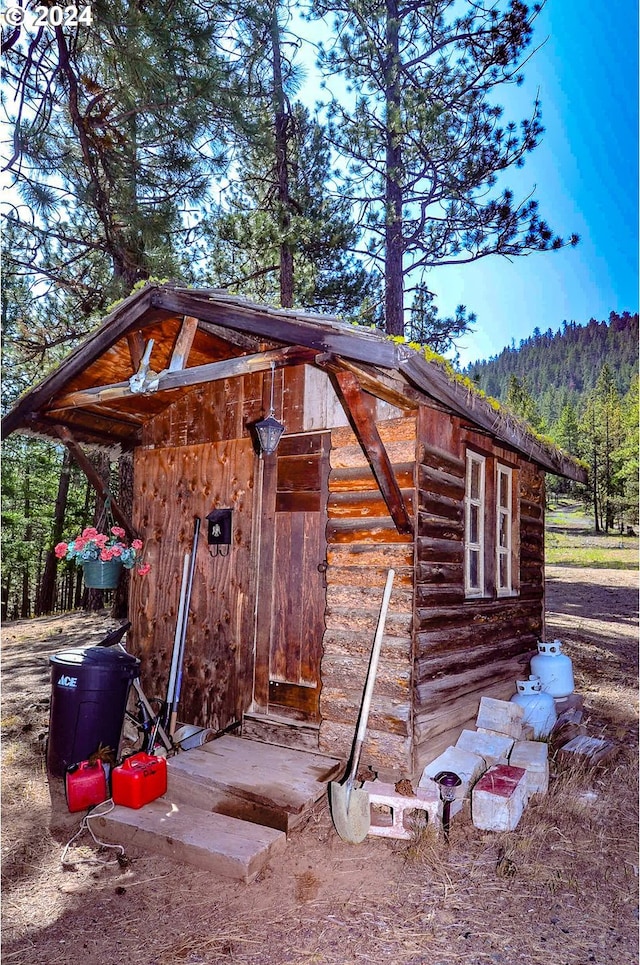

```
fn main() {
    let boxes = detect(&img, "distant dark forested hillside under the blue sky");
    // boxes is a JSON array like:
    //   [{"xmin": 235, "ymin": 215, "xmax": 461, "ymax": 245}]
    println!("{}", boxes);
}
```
[{"xmin": 465, "ymin": 312, "xmax": 638, "ymax": 427}]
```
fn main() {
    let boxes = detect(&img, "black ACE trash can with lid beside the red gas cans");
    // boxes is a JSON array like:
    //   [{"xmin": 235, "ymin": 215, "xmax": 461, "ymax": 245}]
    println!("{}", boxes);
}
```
[{"xmin": 47, "ymin": 646, "xmax": 140, "ymax": 777}]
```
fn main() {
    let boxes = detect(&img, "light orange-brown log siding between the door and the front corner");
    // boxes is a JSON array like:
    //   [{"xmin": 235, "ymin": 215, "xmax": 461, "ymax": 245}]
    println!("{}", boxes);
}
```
[{"xmin": 319, "ymin": 417, "xmax": 416, "ymax": 775}]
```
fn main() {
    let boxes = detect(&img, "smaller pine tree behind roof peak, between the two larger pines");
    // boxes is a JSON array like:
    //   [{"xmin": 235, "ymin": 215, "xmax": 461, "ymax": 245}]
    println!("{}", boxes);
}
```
[{"xmin": 207, "ymin": 102, "xmax": 379, "ymax": 323}]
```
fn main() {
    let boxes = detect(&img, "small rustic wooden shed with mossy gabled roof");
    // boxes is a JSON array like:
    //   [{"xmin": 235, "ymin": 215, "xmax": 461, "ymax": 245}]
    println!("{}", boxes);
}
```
[{"xmin": 3, "ymin": 284, "xmax": 584, "ymax": 779}]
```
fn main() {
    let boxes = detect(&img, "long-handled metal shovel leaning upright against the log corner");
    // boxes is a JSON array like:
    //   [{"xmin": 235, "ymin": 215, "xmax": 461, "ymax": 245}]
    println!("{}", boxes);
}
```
[{"xmin": 329, "ymin": 570, "xmax": 395, "ymax": 844}]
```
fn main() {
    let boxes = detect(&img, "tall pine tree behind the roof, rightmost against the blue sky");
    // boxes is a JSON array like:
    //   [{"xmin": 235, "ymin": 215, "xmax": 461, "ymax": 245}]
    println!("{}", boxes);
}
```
[{"xmin": 313, "ymin": 0, "xmax": 577, "ymax": 335}]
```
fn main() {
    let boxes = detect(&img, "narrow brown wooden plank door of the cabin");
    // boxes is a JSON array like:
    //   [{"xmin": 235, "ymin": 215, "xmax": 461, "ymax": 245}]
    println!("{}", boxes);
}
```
[{"xmin": 254, "ymin": 432, "xmax": 329, "ymax": 723}]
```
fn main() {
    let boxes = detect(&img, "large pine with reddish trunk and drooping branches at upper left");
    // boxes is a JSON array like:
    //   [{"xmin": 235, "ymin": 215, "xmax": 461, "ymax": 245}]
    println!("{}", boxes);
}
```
[{"xmin": 5, "ymin": 0, "xmax": 242, "ymax": 317}]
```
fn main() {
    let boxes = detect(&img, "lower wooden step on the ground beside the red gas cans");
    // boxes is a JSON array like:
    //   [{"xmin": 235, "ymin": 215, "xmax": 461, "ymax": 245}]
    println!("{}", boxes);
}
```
[{"xmin": 91, "ymin": 797, "xmax": 287, "ymax": 882}]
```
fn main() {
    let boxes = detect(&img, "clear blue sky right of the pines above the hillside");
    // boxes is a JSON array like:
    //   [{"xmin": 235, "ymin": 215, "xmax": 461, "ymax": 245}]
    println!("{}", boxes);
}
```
[{"xmin": 298, "ymin": 0, "xmax": 639, "ymax": 365}]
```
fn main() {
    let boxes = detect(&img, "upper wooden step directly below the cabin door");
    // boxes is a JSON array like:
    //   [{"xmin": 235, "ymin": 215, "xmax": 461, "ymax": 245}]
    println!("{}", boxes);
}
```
[{"xmin": 167, "ymin": 735, "xmax": 342, "ymax": 833}]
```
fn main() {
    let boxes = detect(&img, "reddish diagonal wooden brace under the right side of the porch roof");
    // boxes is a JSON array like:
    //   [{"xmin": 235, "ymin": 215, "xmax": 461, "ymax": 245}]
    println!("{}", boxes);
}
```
[{"xmin": 333, "ymin": 369, "xmax": 413, "ymax": 535}]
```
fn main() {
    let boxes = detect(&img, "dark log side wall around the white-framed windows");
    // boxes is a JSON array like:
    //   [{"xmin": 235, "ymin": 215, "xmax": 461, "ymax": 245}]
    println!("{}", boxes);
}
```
[{"xmin": 414, "ymin": 407, "xmax": 544, "ymax": 773}]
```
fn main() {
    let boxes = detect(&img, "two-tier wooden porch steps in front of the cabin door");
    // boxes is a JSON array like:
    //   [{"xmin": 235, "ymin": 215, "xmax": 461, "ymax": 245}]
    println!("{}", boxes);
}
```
[{"xmin": 92, "ymin": 735, "xmax": 343, "ymax": 882}]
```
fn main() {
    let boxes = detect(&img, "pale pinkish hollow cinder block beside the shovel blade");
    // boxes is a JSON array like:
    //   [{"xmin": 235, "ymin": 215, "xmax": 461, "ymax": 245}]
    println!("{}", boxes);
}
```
[{"xmin": 363, "ymin": 781, "xmax": 442, "ymax": 841}]
